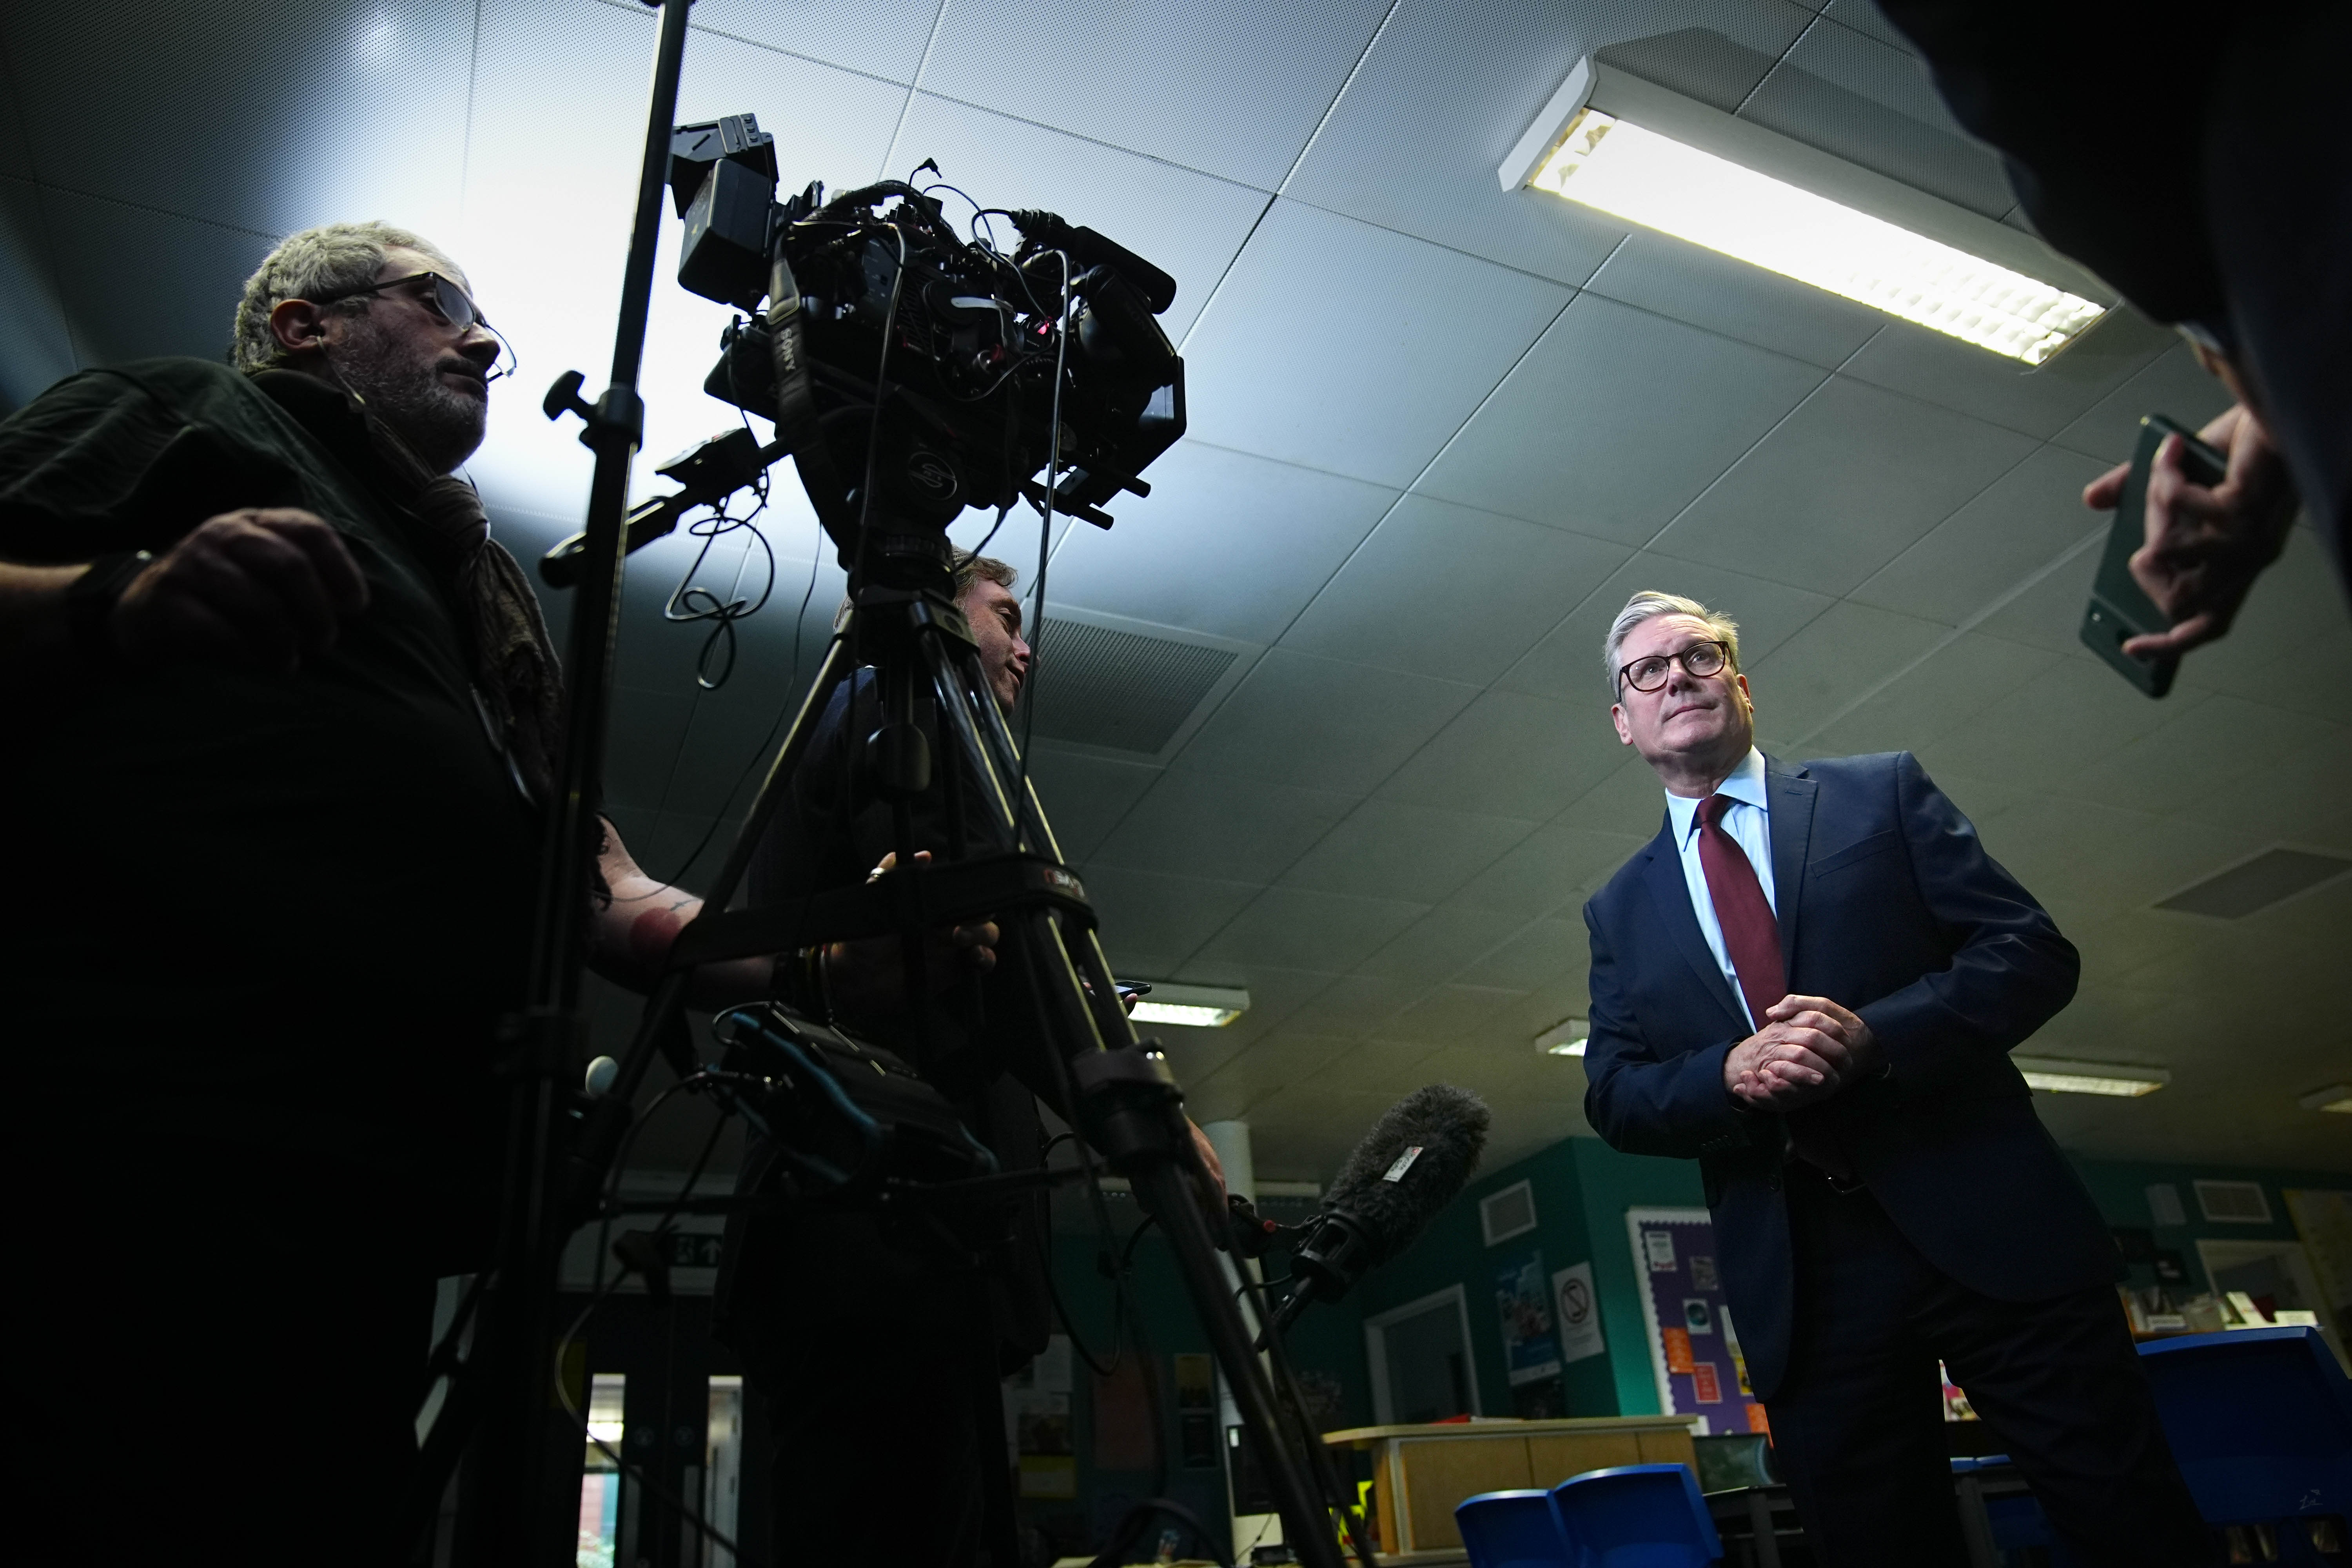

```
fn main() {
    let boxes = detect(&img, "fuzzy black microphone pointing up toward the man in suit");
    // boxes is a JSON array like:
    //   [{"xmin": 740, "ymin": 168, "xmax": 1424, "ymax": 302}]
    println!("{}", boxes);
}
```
[{"xmin": 1275, "ymin": 1084, "xmax": 1494, "ymax": 1333}]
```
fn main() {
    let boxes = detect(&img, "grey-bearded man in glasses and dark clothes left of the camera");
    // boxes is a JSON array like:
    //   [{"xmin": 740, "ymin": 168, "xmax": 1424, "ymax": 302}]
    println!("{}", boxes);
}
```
[{"xmin": 0, "ymin": 223, "xmax": 734, "ymax": 1563}]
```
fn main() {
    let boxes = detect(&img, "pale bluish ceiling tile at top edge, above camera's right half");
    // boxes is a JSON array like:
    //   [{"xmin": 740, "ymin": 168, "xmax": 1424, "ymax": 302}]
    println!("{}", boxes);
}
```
[{"xmin": 922, "ymin": 0, "xmax": 1388, "ymax": 191}]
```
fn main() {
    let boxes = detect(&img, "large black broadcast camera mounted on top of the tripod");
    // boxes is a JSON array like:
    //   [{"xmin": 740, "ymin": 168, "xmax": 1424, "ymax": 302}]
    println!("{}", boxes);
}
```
[{"xmin": 670, "ymin": 115, "xmax": 1185, "ymax": 585}]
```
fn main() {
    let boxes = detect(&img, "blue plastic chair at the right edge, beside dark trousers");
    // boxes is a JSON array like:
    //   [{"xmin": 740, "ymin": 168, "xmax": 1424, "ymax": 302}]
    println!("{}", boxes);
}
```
[{"xmin": 2140, "ymin": 1326, "xmax": 2352, "ymax": 1563}]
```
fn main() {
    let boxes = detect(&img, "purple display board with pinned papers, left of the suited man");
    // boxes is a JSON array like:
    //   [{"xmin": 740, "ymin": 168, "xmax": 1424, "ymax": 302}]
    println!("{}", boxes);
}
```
[{"xmin": 1625, "ymin": 1208, "xmax": 1766, "ymax": 1432}]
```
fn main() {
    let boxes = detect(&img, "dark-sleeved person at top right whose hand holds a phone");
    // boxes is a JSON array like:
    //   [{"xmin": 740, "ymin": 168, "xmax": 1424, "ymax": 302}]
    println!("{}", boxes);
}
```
[{"xmin": 1879, "ymin": 0, "xmax": 2352, "ymax": 658}]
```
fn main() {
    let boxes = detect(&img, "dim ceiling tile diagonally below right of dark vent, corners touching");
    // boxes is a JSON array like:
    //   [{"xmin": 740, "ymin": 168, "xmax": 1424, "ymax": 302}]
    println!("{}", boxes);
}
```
[{"xmin": 1096, "ymin": 773, "xmax": 1359, "ymax": 884}]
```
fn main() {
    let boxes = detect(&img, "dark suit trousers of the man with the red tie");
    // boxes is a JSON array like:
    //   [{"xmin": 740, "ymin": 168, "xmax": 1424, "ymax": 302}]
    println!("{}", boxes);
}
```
[{"xmin": 1766, "ymin": 1166, "xmax": 2220, "ymax": 1568}]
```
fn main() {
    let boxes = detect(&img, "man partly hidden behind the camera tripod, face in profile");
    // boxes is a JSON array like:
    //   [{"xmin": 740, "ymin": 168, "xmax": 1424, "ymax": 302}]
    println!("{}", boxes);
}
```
[{"xmin": 717, "ymin": 552, "xmax": 1223, "ymax": 1568}]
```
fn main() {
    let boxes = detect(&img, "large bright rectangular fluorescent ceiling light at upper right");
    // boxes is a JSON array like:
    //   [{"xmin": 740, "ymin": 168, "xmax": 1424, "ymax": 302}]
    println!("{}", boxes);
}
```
[{"xmin": 1496, "ymin": 59, "xmax": 2112, "ymax": 365}]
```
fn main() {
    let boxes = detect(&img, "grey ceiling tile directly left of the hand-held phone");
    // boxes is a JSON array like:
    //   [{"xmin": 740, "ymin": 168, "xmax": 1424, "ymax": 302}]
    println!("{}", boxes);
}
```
[{"xmin": 1853, "ymin": 446, "xmax": 2105, "ymax": 625}]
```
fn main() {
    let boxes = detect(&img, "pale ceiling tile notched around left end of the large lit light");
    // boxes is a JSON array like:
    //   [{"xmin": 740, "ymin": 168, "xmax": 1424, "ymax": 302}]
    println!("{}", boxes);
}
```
[{"xmin": 1287, "ymin": 0, "xmax": 1811, "ymax": 285}]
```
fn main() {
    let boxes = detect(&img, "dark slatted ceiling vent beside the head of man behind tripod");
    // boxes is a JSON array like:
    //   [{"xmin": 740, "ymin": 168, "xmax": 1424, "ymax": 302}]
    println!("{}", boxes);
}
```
[{"xmin": 1014, "ymin": 616, "xmax": 1235, "ymax": 755}]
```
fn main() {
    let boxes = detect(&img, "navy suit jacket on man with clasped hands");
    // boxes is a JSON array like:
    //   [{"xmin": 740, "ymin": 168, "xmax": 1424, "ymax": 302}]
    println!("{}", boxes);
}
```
[{"xmin": 1585, "ymin": 752, "xmax": 2119, "ymax": 1399}]
